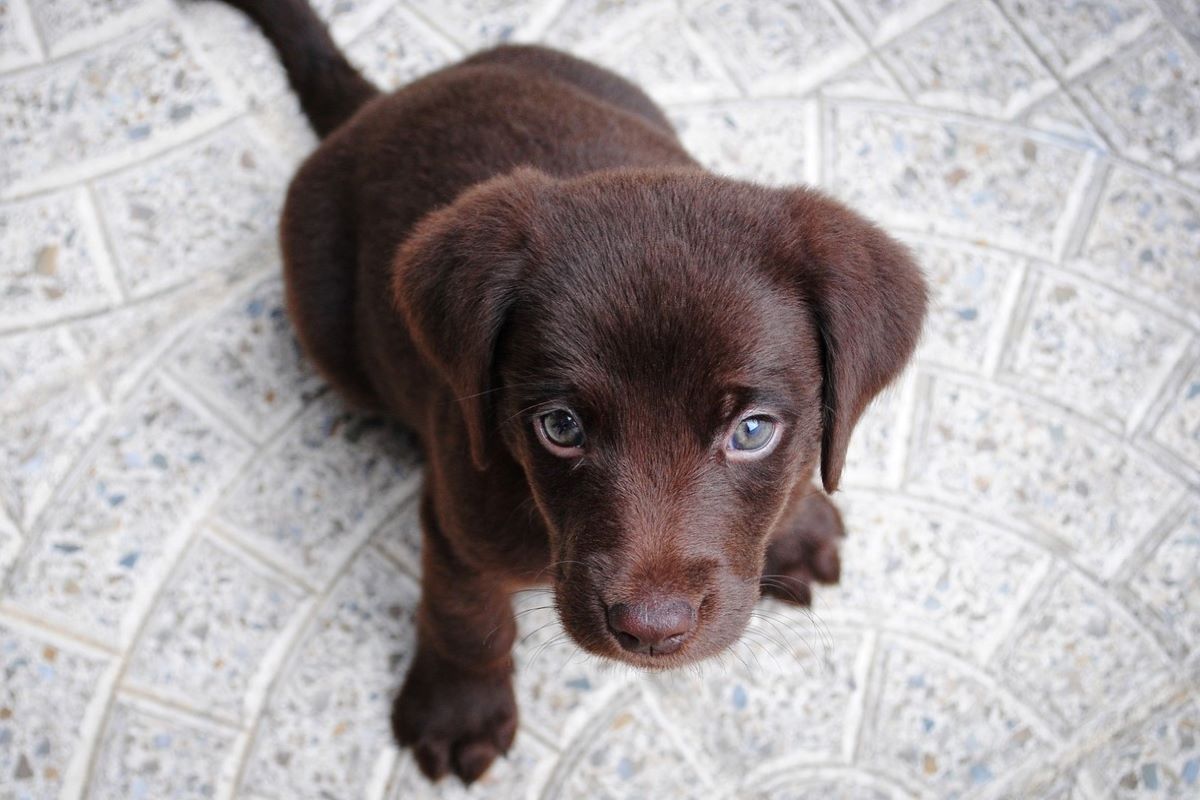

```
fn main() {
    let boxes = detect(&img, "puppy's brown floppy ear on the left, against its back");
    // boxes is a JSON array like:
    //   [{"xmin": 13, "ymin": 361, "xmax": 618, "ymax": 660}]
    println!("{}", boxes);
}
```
[{"xmin": 392, "ymin": 169, "xmax": 552, "ymax": 469}]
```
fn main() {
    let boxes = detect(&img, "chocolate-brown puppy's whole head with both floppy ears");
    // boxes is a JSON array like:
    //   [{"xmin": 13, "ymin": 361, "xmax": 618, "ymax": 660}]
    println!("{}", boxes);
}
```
[{"xmin": 396, "ymin": 170, "xmax": 924, "ymax": 667}]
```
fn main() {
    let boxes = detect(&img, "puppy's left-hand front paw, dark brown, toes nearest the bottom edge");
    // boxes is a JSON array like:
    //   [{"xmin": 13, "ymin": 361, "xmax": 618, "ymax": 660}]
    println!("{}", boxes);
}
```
[{"xmin": 391, "ymin": 651, "xmax": 517, "ymax": 784}]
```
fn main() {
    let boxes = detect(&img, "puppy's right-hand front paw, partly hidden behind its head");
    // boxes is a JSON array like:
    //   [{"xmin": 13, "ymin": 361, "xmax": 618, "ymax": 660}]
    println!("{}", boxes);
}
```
[{"xmin": 760, "ymin": 489, "xmax": 846, "ymax": 606}]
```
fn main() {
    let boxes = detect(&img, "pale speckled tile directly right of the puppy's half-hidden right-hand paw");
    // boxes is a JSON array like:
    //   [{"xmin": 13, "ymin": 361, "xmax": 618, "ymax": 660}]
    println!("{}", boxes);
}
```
[{"xmin": 817, "ymin": 489, "xmax": 1051, "ymax": 657}]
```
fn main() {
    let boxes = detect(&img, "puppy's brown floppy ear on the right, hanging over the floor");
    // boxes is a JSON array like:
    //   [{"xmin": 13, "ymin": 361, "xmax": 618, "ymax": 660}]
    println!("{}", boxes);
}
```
[{"xmin": 782, "ymin": 190, "xmax": 928, "ymax": 492}]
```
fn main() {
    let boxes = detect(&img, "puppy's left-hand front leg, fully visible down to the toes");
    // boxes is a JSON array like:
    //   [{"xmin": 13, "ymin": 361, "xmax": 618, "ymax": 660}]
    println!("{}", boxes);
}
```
[{"xmin": 391, "ymin": 494, "xmax": 517, "ymax": 783}]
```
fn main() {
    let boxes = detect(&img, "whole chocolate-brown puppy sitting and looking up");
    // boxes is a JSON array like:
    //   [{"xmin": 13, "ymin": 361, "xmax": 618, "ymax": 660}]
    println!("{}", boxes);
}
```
[{"xmin": 218, "ymin": 0, "xmax": 926, "ymax": 783}]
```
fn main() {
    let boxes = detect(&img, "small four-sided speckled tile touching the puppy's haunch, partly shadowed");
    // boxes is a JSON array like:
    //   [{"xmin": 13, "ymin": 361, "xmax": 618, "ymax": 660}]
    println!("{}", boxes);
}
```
[{"xmin": 168, "ymin": 275, "xmax": 324, "ymax": 437}]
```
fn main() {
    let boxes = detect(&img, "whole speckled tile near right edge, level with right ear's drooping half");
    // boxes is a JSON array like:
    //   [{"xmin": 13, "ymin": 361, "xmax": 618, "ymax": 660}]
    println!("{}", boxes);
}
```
[{"xmin": 1003, "ymin": 267, "xmax": 1189, "ymax": 431}]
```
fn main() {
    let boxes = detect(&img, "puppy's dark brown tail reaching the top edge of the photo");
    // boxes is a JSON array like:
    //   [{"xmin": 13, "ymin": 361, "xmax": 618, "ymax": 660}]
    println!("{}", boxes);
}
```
[{"xmin": 224, "ymin": 0, "xmax": 379, "ymax": 139}]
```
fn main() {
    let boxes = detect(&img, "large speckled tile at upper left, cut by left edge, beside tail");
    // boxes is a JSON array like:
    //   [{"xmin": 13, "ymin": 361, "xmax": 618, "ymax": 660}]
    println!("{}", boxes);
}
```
[{"xmin": 0, "ymin": 22, "xmax": 230, "ymax": 193}]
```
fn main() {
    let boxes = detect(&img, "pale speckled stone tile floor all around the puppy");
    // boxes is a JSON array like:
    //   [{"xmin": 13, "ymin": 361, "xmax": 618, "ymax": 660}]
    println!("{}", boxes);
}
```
[{"xmin": 0, "ymin": 0, "xmax": 1200, "ymax": 800}]
